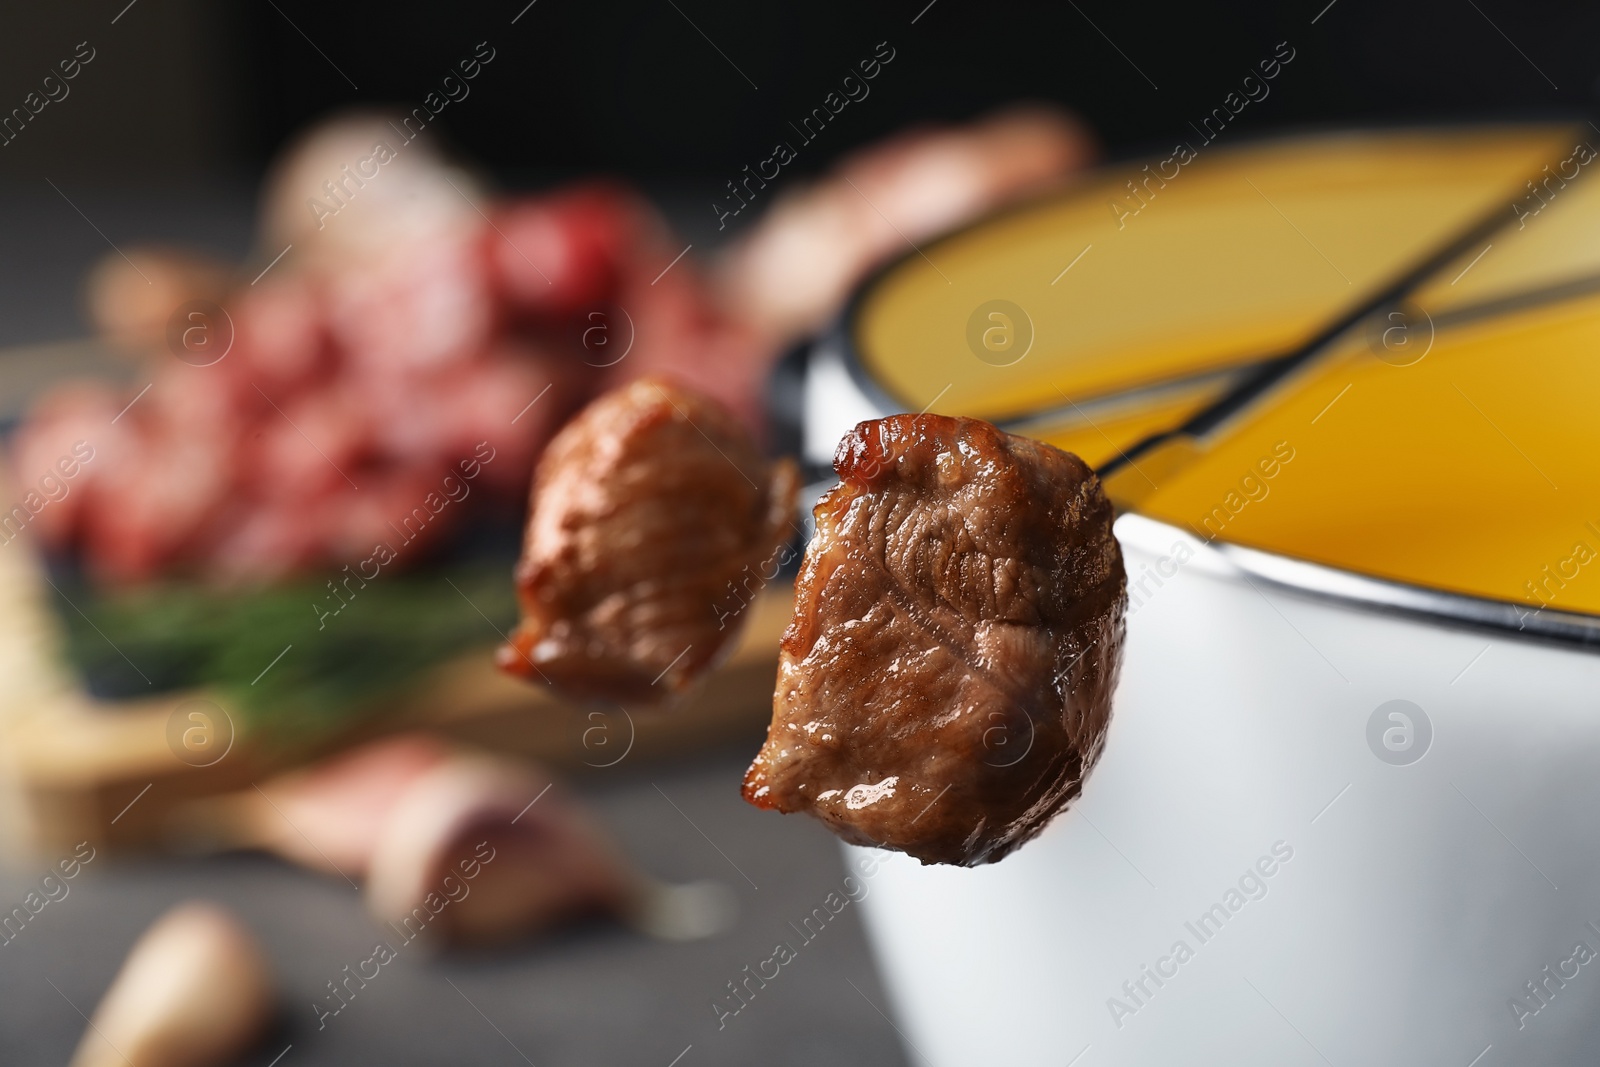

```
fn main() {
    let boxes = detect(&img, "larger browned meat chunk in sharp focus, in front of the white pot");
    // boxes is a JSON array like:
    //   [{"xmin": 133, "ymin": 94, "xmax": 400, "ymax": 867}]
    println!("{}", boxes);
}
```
[{"xmin": 744, "ymin": 414, "xmax": 1126, "ymax": 867}]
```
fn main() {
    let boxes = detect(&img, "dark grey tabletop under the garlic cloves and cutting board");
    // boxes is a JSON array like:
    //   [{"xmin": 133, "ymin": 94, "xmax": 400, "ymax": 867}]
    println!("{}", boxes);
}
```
[{"xmin": 0, "ymin": 183, "xmax": 907, "ymax": 1067}]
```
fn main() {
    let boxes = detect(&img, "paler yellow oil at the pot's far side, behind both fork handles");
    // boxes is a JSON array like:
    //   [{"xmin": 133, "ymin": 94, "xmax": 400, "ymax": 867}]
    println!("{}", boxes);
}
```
[{"xmin": 853, "ymin": 126, "xmax": 1580, "ymax": 421}]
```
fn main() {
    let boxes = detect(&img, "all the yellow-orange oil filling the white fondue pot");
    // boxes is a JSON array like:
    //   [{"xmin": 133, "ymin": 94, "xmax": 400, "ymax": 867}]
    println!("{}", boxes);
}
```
[{"xmin": 854, "ymin": 126, "xmax": 1600, "ymax": 614}]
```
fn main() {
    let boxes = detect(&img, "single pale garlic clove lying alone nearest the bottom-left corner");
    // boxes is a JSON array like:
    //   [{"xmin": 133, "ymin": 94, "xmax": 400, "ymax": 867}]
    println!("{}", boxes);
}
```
[{"xmin": 70, "ymin": 901, "xmax": 274, "ymax": 1067}]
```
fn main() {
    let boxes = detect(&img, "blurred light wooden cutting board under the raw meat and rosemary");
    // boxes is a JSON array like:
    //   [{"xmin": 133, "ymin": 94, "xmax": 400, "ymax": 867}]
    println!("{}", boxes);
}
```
[{"xmin": 0, "ymin": 479, "xmax": 794, "ymax": 856}]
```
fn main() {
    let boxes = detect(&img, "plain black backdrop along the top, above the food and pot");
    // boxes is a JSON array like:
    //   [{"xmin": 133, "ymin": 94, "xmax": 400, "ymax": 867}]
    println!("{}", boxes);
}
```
[{"xmin": 0, "ymin": 0, "xmax": 1600, "ymax": 181}]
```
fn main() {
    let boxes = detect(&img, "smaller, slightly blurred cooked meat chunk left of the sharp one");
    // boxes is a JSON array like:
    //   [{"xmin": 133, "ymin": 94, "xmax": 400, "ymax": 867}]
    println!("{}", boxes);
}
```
[{"xmin": 496, "ymin": 379, "xmax": 800, "ymax": 702}]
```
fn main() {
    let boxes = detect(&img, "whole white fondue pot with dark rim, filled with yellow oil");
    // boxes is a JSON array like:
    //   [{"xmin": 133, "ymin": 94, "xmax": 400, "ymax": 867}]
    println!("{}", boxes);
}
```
[{"xmin": 800, "ymin": 123, "xmax": 1600, "ymax": 1067}]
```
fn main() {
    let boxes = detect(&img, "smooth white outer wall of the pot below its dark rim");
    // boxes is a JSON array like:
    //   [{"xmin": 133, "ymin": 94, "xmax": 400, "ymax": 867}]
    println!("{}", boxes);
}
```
[{"xmin": 846, "ymin": 517, "xmax": 1600, "ymax": 1067}]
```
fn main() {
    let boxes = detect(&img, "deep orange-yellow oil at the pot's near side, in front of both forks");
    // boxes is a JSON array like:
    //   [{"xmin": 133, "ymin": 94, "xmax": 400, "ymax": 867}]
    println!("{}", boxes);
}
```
[{"xmin": 1138, "ymin": 292, "xmax": 1600, "ymax": 613}]
